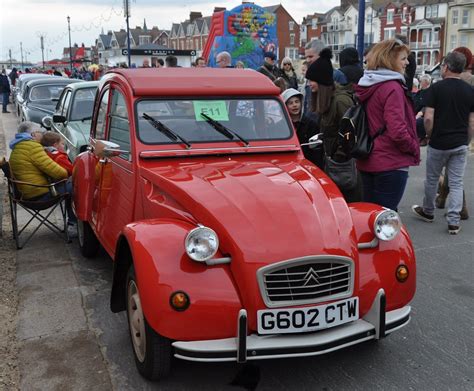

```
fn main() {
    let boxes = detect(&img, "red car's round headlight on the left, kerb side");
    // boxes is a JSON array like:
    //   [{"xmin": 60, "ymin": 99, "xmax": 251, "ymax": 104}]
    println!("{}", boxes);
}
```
[{"xmin": 184, "ymin": 227, "xmax": 219, "ymax": 262}]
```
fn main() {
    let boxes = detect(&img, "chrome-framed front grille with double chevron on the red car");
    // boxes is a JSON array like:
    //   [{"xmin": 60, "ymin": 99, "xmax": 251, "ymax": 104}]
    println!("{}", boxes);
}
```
[{"xmin": 259, "ymin": 257, "xmax": 354, "ymax": 307}]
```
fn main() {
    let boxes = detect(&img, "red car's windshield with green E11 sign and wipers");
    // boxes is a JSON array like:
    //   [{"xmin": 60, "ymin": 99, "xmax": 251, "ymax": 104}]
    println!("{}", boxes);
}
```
[{"xmin": 137, "ymin": 98, "xmax": 292, "ymax": 145}]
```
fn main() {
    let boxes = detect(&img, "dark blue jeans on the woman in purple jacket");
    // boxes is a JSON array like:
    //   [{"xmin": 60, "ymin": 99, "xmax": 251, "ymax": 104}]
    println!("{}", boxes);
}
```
[{"xmin": 360, "ymin": 170, "xmax": 408, "ymax": 210}]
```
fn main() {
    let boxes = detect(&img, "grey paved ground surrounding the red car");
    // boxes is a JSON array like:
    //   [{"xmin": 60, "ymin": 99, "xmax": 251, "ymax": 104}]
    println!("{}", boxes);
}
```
[{"xmin": 4, "ymin": 110, "xmax": 474, "ymax": 391}]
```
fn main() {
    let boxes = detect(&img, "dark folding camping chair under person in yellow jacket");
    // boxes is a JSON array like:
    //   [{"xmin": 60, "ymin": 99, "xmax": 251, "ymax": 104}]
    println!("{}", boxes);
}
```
[{"xmin": 0, "ymin": 158, "xmax": 70, "ymax": 249}]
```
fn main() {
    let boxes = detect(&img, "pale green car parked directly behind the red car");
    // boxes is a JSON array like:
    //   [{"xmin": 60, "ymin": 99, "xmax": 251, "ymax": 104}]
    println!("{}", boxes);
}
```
[{"xmin": 42, "ymin": 81, "xmax": 99, "ymax": 161}]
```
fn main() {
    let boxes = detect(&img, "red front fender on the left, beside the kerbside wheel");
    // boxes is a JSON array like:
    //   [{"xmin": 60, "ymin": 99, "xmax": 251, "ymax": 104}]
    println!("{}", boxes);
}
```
[{"xmin": 124, "ymin": 219, "xmax": 242, "ymax": 340}]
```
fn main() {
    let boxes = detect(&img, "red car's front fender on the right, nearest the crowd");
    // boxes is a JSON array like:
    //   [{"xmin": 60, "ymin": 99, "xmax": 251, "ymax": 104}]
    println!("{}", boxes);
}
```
[{"xmin": 349, "ymin": 203, "xmax": 416, "ymax": 315}]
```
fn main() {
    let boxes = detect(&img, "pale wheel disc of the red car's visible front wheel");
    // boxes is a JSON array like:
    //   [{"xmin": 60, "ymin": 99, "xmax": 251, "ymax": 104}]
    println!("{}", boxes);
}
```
[{"xmin": 127, "ymin": 280, "xmax": 146, "ymax": 362}]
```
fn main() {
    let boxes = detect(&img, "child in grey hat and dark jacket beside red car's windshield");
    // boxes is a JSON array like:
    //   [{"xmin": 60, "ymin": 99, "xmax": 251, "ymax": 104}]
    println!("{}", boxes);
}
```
[{"xmin": 281, "ymin": 88, "xmax": 324, "ymax": 169}]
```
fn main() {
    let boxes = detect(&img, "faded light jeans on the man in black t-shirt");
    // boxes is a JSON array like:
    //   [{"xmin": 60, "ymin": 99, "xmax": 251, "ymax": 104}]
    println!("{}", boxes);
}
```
[{"xmin": 423, "ymin": 145, "xmax": 468, "ymax": 225}]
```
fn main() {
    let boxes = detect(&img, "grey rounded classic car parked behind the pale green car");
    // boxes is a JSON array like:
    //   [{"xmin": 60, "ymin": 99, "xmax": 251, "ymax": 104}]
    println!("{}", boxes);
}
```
[{"xmin": 20, "ymin": 77, "xmax": 80, "ymax": 124}]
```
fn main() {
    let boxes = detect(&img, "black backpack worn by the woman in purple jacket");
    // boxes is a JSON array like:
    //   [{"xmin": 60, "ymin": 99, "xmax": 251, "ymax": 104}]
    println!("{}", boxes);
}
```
[{"xmin": 339, "ymin": 100, "xmax": 385, "ymax": 159}]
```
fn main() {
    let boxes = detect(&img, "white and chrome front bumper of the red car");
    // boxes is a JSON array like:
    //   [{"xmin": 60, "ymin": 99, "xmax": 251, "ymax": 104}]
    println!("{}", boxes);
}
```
[{"xmin": 172, "ymin": 289, "xmax": 411, "ymax": 362}]
